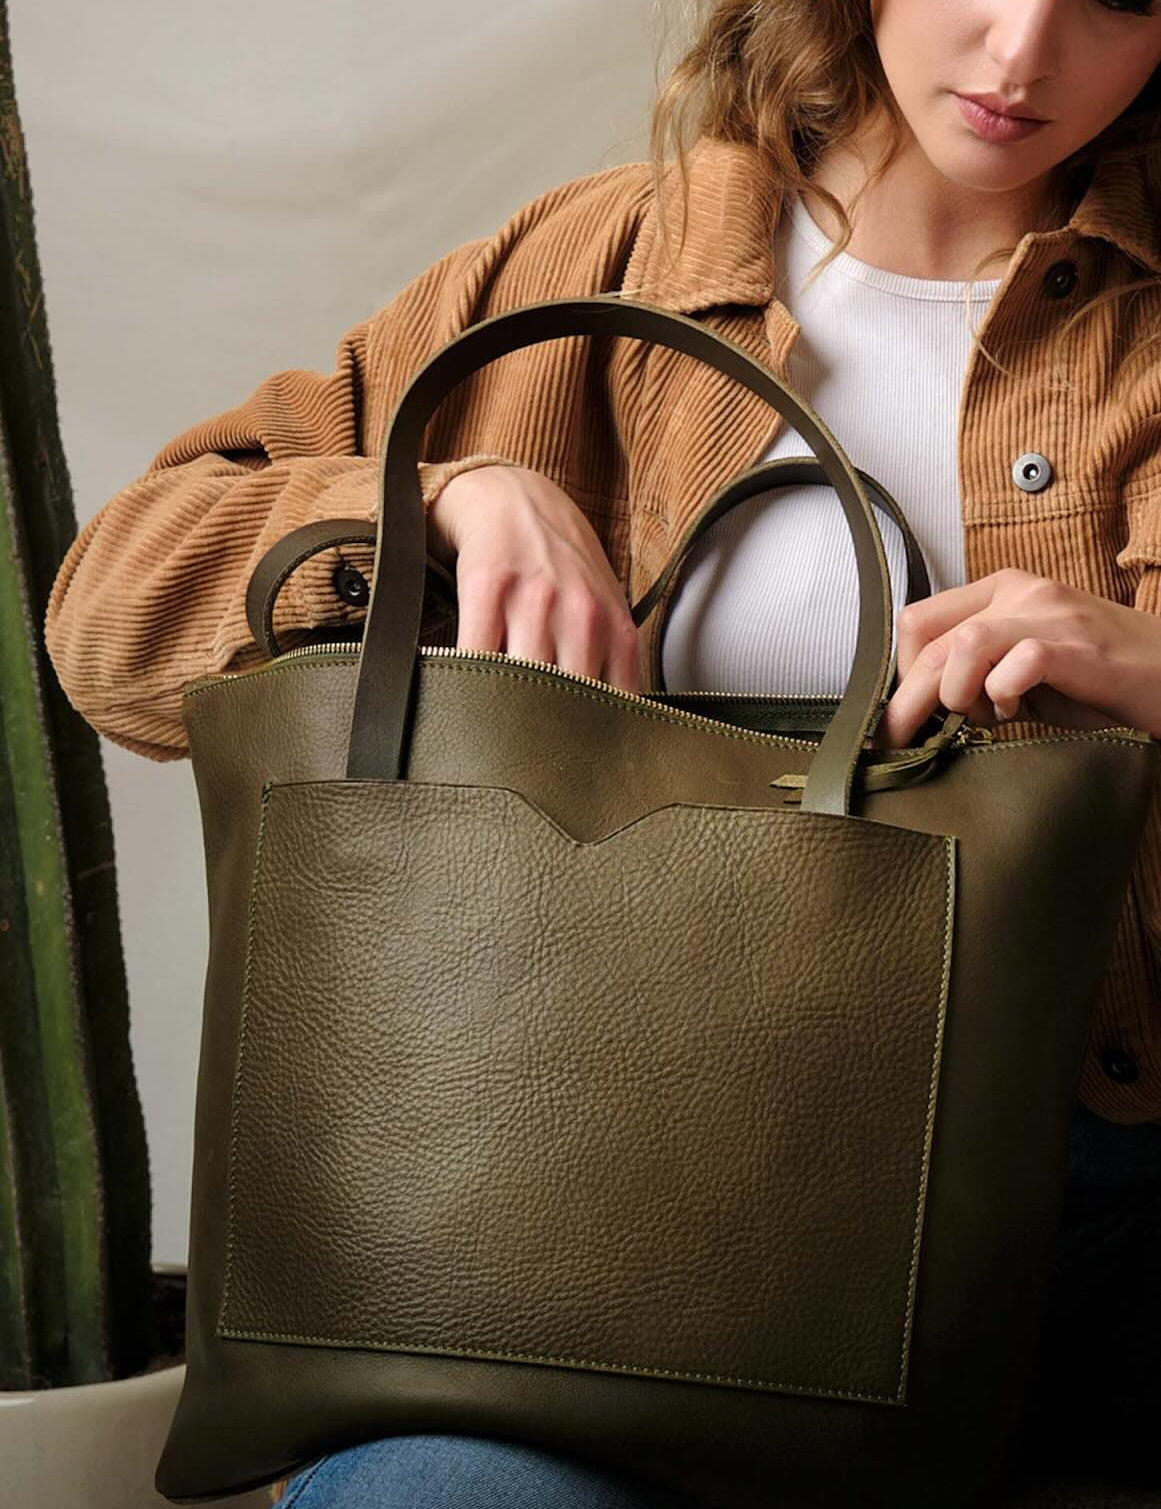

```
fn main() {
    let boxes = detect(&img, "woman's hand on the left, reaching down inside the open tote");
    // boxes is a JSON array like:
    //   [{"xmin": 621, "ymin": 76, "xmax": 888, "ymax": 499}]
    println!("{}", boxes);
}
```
[{"xmin": 427, "ymin": 466, "xmax": 640, "ymax": 693}]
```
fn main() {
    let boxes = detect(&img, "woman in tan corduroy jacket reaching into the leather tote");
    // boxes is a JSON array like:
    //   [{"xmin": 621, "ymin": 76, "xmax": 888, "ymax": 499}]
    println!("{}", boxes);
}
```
[{"xmin": 47, "ymin": 0, "xmax": 1161, "ymax": 1509}]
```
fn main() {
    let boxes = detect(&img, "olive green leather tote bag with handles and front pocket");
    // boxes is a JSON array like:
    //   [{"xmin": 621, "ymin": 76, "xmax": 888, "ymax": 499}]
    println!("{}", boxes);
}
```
[{"xmin": 157, "ymin": 296, "xmax": 1158, "ymax": 1509}]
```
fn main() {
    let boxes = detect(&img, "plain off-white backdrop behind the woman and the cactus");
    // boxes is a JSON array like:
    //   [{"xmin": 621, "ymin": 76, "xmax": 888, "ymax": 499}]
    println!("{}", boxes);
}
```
[{"xmin": 9, "ymin": 0, "xmax": 658, "ymax": 1263}]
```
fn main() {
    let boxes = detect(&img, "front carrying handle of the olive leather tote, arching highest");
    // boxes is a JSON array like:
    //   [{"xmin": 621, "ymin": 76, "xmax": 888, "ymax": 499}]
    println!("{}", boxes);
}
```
[{"xmin": 347, "ymin": 294, "xmax": 892, "ymax": 816}]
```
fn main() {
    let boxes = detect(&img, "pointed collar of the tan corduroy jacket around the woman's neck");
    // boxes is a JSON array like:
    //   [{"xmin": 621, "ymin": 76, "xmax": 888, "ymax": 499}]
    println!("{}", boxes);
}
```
[{"xmin": 622, "ymin": 136, "xmax": 1161, "ymax": 314}]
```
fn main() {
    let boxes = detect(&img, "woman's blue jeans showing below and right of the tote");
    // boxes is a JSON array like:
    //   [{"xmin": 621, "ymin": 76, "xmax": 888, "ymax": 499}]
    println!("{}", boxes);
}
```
[{"xmin": 282, "ymin": 1106, "xmax": 1161, "ymax": 1509}]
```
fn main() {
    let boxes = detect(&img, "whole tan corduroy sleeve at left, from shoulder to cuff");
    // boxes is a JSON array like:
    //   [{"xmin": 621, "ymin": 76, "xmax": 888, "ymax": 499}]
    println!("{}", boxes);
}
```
[{"xmin": 45, "ymin": 156, "xmax": 651, "ymax": 759}]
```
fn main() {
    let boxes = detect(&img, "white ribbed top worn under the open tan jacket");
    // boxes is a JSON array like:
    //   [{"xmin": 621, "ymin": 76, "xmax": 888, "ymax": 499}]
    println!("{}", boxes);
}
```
[{"xmin": 661, "ymin": 198, "xmax": 1001, "ymax": 696}]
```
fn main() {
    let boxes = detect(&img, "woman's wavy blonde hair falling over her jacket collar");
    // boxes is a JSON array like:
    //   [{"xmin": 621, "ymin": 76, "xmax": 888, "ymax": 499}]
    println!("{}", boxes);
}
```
[{"xmin": 651, "ymin": 0, "xmax": 1161, "ymax": 377}]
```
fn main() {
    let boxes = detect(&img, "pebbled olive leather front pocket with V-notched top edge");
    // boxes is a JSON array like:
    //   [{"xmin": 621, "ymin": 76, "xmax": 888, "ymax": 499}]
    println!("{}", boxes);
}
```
[{"xmin": 219, "ymin": 782, "xmax": 954, "ymax": 1403}]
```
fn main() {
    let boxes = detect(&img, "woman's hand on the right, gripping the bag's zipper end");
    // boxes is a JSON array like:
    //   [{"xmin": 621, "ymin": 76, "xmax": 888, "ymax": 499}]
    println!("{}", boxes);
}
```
[{"xmin": 876, "ymin": 569, "xmax": 1161, "ymax": 748}]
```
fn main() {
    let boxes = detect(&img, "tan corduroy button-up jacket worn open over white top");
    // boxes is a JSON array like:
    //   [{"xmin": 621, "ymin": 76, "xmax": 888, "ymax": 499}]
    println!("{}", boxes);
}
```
[{"xmin": 47, "ymin": 139, "xmax": 1161, "ymax": 1123}]
